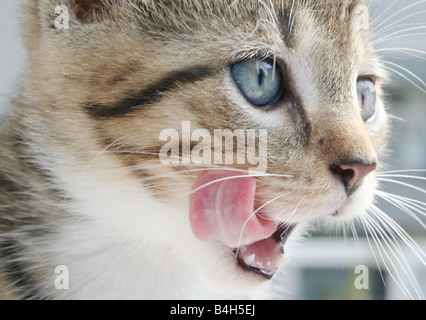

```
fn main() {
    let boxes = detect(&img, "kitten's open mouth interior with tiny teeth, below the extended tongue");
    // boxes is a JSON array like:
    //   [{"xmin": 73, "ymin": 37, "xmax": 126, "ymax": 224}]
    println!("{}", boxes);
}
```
[{"xmin": 234, "ymin": 225, "xmax": 294, "ymax": 280}]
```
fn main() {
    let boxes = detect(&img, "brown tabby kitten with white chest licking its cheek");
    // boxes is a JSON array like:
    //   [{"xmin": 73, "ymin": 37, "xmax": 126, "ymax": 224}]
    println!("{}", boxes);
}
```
[{"xmin": 0, "ymin": 0, "xmax": 416, "ymax": 299}]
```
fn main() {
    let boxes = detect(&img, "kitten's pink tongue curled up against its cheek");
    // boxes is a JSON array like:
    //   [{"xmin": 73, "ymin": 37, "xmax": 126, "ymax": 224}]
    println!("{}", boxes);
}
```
[{"xmin": 189, "ymin": 170, "xmax": 277, "ymax": 248}]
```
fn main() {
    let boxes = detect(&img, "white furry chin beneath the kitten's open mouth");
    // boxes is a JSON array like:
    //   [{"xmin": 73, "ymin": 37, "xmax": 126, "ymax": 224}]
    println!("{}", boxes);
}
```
[{"xmin": 179, "ymin": 223, "xmax": 306, "ymax": 299}]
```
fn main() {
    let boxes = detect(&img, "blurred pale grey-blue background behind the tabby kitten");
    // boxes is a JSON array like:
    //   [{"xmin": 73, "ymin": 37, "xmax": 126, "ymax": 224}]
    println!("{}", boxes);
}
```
[{"xmin": 0, "ymin": 0, "xmax": 426, "ymax": 300}]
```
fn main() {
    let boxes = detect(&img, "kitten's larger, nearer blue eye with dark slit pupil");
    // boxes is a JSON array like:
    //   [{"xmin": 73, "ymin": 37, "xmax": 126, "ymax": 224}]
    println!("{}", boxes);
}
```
[{"xmin": 231, "ymin": 59, "xmax": 283, "ymax": 109}]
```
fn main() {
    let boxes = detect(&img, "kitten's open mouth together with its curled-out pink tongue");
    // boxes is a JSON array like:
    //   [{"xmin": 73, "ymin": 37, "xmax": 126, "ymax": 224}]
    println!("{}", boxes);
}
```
[{"xmin": 189, "ymin": 170, "xmax": 294, "ymax": 279}]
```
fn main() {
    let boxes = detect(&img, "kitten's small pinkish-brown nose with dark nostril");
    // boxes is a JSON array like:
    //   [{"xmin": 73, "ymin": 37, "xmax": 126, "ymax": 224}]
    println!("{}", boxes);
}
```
[{"xmin": 330, "ymin": 162, "xmax": 377, "ymax": 196}]
